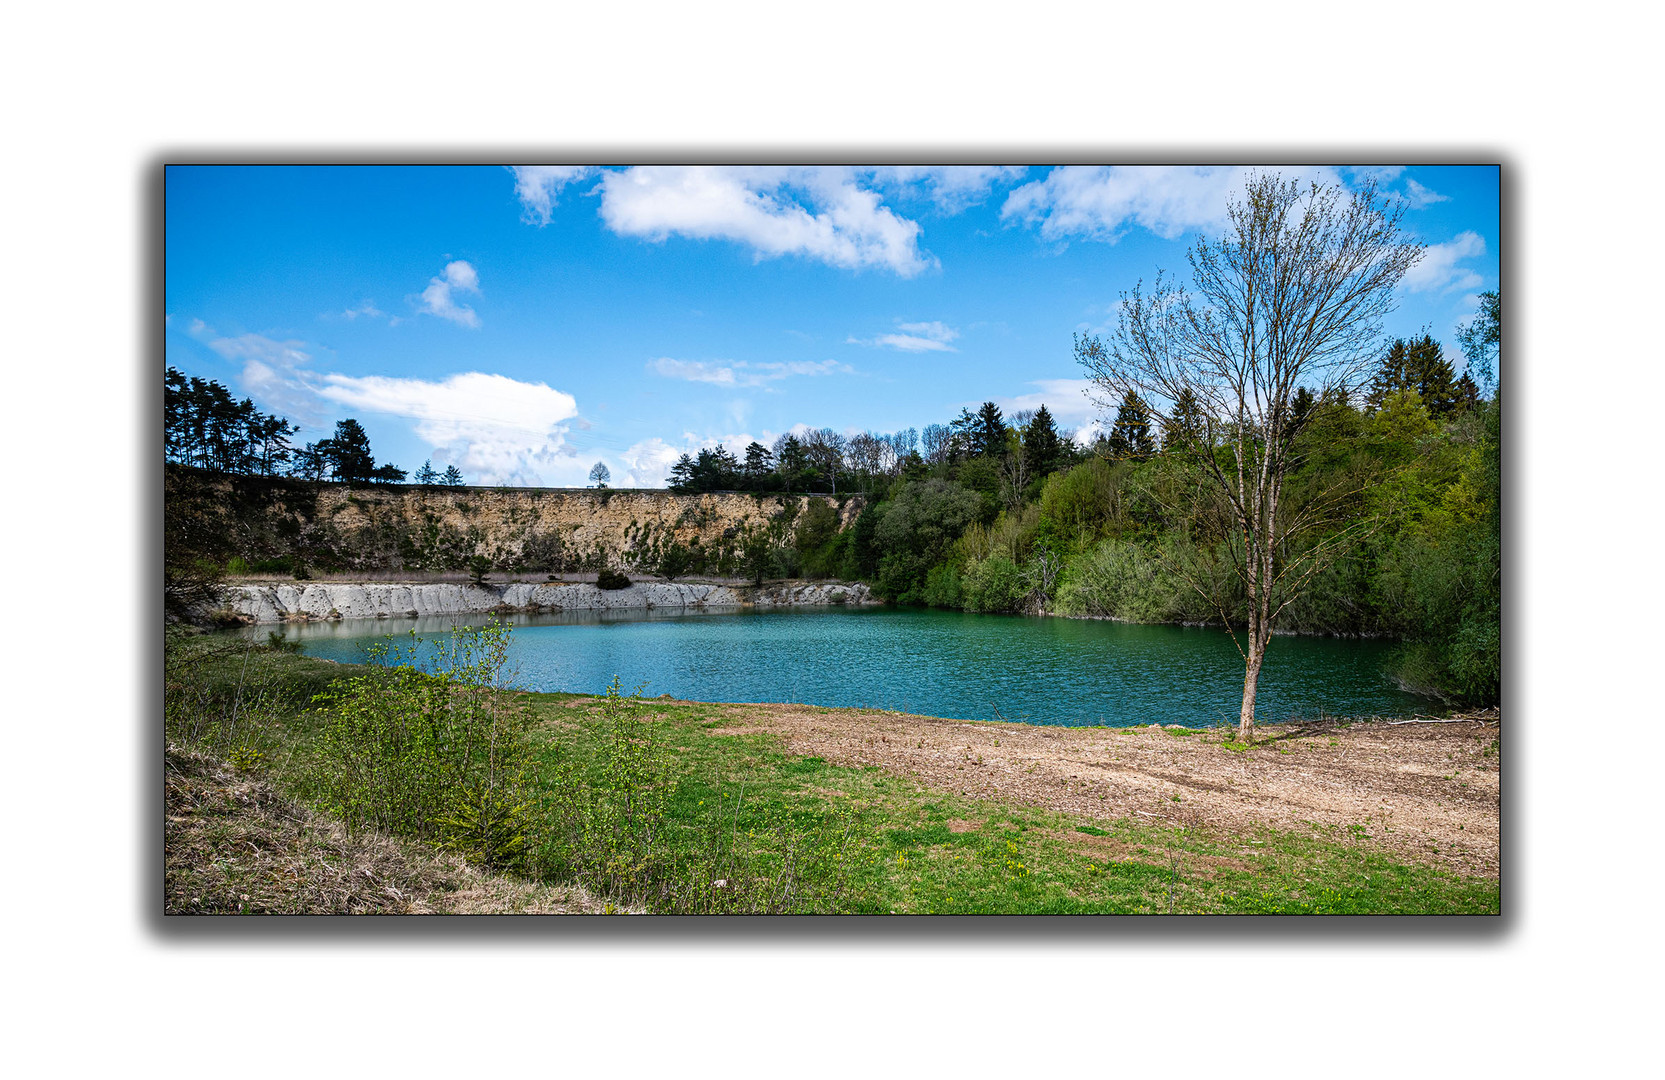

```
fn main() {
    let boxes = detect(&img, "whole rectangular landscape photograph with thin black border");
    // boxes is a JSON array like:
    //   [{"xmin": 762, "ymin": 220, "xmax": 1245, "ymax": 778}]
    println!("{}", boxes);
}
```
[{"xmin": 157, "ymin": 161, "xmax": 1503, "ymax": 917}]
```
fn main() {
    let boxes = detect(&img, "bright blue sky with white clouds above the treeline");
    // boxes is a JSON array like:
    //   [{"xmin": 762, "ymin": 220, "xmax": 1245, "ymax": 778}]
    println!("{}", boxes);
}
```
[{"xmin": 165, "ymin": 166, "xmax": 1499, "ymax": 486}]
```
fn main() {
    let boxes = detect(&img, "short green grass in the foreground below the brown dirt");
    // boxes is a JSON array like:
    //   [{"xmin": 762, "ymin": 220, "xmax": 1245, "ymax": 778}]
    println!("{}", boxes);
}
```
[{"xmin": 533, "ymin": 696, "xmax": 1499, "ymax": 915}]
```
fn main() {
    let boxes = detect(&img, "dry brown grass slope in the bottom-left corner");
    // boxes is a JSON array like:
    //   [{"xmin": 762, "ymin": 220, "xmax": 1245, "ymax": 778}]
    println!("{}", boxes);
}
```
[{"xmin": 163, "ymin": 746, "xmax": 636, "ymax": 915}]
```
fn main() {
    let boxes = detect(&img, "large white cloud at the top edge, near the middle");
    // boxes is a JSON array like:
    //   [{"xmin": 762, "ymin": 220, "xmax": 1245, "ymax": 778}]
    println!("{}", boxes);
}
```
[{"xmin": 601, "ymin": 165, "xmax": 937, "ymax": 278}]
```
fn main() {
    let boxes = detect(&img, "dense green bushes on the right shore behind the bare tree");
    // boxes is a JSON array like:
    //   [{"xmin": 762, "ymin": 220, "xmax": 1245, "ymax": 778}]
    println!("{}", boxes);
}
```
[{"xmin": 822, "ymin": 386, "xmax": 1502, "ymax": 704}]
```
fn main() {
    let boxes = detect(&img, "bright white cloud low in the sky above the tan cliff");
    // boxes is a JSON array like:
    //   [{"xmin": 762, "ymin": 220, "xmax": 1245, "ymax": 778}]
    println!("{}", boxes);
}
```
[{"xmin": 316, "ymin": 371, "xmax": 589, "ymax": 486}]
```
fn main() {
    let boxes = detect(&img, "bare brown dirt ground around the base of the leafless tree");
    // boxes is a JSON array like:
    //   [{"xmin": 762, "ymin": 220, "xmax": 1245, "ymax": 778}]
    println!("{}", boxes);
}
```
[{"xmin": 695, "ymin": 706, "xmax": 1500, "ymax": 879}]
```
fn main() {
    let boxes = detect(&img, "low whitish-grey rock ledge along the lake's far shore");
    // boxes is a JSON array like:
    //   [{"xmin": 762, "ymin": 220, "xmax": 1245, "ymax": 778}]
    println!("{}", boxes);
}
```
[{"xmin": 225, "ymin": 582, "xmax": 876, "ymax": 624}]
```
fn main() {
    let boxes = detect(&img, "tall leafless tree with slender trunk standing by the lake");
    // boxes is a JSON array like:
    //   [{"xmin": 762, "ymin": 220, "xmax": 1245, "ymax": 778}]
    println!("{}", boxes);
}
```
[{"xmin": 1076, "ymin": 175, "xmax": 1422, "ymax": 741}]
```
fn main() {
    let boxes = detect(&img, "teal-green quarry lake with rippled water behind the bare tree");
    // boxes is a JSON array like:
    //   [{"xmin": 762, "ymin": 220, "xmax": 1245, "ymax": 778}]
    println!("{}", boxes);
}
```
[{"xmin": 246, "ymin": 607, "xmax": 1432, "ymax": 727}]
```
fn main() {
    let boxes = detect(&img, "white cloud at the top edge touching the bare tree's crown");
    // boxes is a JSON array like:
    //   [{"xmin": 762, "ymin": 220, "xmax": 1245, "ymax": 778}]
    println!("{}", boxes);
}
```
[{"xmin": 1001, "ymin": 165, "xmax": 1340, "ymax": 243}]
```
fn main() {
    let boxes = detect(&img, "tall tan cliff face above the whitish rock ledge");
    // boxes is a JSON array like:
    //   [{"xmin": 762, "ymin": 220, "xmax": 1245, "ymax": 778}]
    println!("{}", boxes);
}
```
[{"xmin": 170, "ymin": 478, "xmax": 862, "ymax": 574}]
